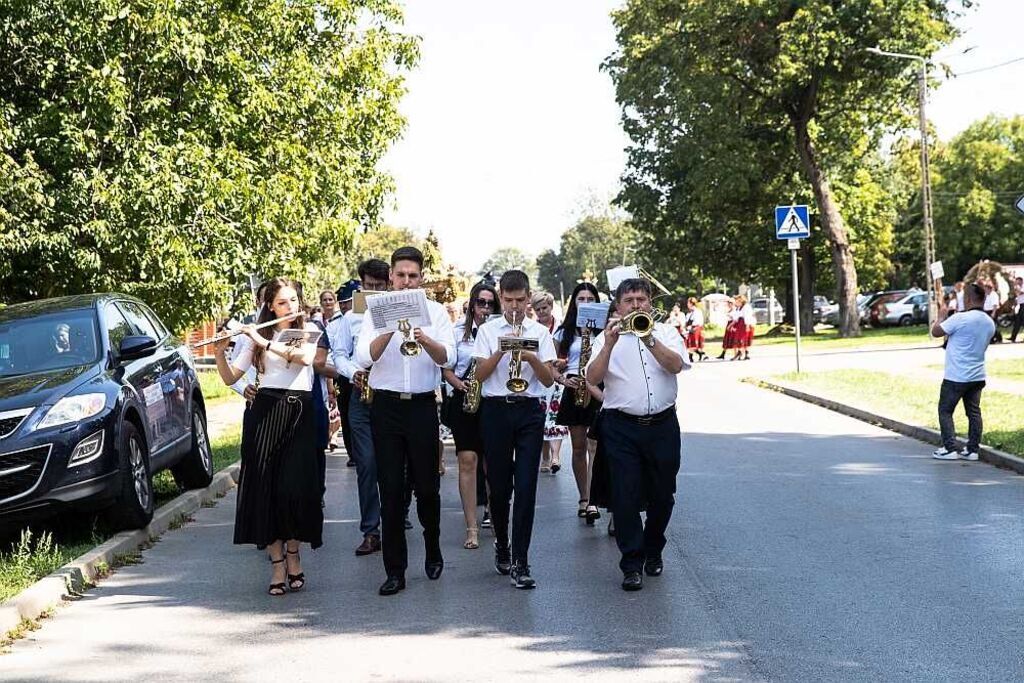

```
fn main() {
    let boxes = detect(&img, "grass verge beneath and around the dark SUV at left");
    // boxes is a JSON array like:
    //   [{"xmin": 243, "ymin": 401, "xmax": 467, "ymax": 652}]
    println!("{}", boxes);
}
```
[{"xmin": 0, "ymin": 430, "xmax": 241, "ymax": 602}]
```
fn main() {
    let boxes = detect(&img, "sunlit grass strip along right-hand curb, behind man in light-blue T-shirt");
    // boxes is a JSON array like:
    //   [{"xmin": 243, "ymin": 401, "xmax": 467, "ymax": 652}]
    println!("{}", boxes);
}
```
[{"xmin": 768, "ymin": 370, "xmax": 1024, "ymax": 456}]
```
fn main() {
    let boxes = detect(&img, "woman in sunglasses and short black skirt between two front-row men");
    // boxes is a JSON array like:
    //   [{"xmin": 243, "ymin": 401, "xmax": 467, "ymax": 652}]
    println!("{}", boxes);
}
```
[{"xmin": 441, "ymin": 283, "xmax": 501, "ymax": 550}]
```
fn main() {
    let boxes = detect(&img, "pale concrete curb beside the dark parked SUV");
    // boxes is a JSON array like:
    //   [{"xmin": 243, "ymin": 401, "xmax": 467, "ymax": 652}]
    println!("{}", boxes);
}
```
[{"xmin": 0, "ymin": 463, "xmax": 240, "ymax": 636}]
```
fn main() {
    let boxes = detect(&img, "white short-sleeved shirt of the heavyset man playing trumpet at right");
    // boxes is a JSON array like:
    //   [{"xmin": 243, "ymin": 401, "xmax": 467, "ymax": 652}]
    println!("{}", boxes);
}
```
[{"xmin": 587, "ymin": 323, "xmax": 690, "ymax": 417}]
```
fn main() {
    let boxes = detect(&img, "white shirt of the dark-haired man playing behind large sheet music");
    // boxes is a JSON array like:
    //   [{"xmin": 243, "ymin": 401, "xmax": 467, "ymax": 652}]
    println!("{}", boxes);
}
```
[{"xmin": 355, "ymin": 300, "xmax": 455, "ymax": 393}]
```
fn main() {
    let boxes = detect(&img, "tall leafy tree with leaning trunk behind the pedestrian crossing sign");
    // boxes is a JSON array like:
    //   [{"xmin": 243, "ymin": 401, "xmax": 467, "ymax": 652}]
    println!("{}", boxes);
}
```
[{"xmin": 604, "ymin": 0, "xmax": 967, "ymax": 336}]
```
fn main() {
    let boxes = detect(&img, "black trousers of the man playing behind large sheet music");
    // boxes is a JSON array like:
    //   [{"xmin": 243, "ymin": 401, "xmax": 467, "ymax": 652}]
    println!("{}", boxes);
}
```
[{"xmin": 370, "ymin": 391, "xmax": 441, "ymax": 577}]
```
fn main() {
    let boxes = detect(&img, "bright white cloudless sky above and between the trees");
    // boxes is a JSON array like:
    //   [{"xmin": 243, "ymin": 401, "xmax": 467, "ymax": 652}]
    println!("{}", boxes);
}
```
[{"xmin": 383, "ymin": 0, "xmax": 1024, "ymax": 270}]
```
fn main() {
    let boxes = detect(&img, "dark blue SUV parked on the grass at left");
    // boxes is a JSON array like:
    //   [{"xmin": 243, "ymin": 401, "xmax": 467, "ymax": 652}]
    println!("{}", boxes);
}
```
[{"xmin": 0, "ymin": 294, "xmax": 213, "ymax": 528}]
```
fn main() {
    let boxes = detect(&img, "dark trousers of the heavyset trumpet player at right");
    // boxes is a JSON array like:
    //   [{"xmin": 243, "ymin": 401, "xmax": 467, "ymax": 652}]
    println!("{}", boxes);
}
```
[{"xmin": 601, "ymin": 411, "xmax": 682, "ymax": 572}]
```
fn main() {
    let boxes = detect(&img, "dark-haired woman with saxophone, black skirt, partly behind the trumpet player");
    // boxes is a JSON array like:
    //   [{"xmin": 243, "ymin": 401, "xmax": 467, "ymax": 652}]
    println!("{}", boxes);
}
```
[{"xmin": 554, "ymin": 283, "xmax": 601, "ymax": 524}]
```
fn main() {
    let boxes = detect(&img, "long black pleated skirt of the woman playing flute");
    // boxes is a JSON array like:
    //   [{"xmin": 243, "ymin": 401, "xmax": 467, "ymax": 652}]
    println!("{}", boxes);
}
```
[{"xmin": 234, "ymin": 388, "xmax": 324, "ymax": 548}]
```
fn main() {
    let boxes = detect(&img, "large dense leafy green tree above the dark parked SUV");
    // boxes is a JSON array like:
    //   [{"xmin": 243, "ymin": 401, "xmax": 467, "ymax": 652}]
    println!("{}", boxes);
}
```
[{"xmin": 0, "ymin": 0, "xmax": 417, "ymax": 330}]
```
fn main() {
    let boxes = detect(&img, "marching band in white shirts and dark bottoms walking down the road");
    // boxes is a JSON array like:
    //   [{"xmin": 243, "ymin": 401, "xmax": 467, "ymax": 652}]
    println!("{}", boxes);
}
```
[{"xmin": 215, "ymin": 247, "xmax": 697, "ymax": 596}]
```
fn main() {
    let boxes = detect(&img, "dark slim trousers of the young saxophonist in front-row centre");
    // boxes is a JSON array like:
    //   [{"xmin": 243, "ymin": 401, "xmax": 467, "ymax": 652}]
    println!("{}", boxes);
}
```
[{"xmin": 480, "ymin": 398, "xmax": 544, "ymax": 562}]
